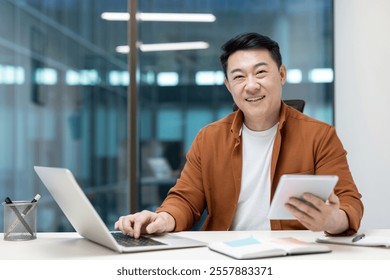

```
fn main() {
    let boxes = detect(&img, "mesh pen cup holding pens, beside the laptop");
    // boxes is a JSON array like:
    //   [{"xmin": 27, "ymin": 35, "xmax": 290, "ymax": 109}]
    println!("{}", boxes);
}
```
[{"xmin": 3, "ymin": 194, "xmax": 41, "ymax": 241}]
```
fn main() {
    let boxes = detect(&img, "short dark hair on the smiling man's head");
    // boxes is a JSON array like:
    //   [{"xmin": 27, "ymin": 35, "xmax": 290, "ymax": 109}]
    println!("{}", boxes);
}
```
[{"xmin": 219, "ymin": 32, "xmax": 282, "ymax": 77}]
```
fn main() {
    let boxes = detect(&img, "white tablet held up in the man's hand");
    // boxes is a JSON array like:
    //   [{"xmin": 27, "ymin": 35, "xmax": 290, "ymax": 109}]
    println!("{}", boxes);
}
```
[{"xmin": 268, "ymin": 174, "xmax": 339, "ymax": 220}]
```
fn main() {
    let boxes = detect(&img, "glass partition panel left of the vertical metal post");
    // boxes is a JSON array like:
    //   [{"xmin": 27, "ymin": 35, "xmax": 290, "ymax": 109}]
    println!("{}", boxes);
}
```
[{"xmin": 0, "ymin": 0, "xmax": 129, "ymax": 231}]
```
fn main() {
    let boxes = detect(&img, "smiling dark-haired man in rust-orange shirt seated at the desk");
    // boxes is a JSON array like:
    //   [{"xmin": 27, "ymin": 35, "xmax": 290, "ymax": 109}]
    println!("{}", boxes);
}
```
[{"xmin": 115, "ymin": 33, "xmax": 363, "ymax": 238}]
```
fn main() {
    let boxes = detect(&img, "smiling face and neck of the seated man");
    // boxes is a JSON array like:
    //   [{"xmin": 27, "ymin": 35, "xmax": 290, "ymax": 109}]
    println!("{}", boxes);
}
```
[{"xmin": 225, "ymin": 49, "xmax": 286, "ymax": 131}]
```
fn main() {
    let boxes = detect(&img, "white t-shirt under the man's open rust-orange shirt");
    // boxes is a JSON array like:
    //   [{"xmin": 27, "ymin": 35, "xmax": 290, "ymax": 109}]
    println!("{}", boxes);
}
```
[{"xmin": 231, "ymin": 124, "xmax": 278, "ymax": 230}]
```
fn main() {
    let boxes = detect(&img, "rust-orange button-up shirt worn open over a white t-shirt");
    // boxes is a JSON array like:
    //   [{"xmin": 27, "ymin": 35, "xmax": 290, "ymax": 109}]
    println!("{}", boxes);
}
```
[{"xmin": 157, "ymin": 103, "xmax": 363, "ymax": 234}]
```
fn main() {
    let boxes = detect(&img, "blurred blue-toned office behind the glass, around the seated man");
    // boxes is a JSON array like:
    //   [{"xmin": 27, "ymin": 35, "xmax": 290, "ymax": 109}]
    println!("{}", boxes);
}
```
[{"xmin": 0, "ymin": 0, "xmax": 335, "ymax": 231}]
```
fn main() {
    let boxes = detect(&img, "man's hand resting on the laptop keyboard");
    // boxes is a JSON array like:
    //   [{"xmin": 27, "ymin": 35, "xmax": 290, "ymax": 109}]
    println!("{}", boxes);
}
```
[{"xmin": 115, "ymin": 210, "xmax": 176, "ymax": 238}]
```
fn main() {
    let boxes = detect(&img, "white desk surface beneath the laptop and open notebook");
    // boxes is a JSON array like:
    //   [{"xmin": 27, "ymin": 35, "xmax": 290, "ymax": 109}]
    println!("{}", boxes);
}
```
[{"xmin": 0, "ymin": 229, "xmax": 390, "ymax": 260}]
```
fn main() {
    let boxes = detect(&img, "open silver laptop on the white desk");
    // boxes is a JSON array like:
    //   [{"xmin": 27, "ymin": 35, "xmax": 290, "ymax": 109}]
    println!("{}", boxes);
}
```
[{"xmin": 34, "ymin": 166, "xmax": 207, "ymax": 253}]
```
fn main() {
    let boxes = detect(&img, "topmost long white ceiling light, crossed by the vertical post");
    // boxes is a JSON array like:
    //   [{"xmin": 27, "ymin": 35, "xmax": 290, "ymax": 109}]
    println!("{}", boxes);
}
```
[{"xmin": 101, "ymin": 12, "xmax": 216, "ymax": 22}]
